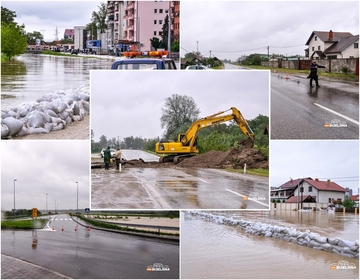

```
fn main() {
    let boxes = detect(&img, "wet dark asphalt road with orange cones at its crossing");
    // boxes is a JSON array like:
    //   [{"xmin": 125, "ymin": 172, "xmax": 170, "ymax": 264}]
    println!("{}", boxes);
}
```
[{"xmin": 1, "ymin": 215, "xmax": 179, "ymax": 279}]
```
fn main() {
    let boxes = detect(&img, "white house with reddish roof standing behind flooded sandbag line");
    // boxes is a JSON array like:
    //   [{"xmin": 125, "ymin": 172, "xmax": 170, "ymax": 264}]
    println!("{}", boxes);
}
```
[{"xmin": 270, "ymin": 178, "xmax": 346, "ymax": 203}]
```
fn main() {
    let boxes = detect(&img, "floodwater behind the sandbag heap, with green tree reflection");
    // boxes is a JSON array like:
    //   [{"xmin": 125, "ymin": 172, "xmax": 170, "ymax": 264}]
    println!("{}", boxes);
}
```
[{"xmin": 1, "ymin": 54, "xmax": 112, "ymax": 108}]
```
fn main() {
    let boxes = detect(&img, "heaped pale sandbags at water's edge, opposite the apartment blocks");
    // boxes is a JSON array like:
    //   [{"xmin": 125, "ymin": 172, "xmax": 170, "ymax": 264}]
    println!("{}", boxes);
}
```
[{"xmin": 1, "ymin": 86, "xmax": 90, "ymax": 139}]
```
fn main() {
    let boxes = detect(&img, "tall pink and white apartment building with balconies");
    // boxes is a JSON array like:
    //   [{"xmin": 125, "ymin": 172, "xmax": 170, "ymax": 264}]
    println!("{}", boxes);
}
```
[{"xmin": 107, "ymin": 1, "xmax": 180, "ymax": 51}]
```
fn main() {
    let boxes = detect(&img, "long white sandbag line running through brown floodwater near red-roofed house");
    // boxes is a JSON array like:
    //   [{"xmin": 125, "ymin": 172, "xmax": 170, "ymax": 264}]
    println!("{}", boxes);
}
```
[{"xmin": 185, "ymin": 211, "xmax": 359, "ymax": 259}]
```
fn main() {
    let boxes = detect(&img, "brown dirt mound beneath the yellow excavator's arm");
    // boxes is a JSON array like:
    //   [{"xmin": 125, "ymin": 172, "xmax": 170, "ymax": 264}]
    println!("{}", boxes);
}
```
[{"xmin": 177, "ymin": 148, "xmax": 269, "ymax": 169}]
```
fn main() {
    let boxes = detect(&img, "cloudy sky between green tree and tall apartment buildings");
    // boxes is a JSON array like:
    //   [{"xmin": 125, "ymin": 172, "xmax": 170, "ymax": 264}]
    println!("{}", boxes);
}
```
[{"xmin": 1, "ymin": 0, "xmax": 102, "ymax": 41}]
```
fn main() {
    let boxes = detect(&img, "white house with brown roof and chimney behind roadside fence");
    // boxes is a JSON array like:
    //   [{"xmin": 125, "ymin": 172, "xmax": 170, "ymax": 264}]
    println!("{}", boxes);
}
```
[{"xmin": 305, "ymin": 30, "xmax": 359, "ymax": 59}]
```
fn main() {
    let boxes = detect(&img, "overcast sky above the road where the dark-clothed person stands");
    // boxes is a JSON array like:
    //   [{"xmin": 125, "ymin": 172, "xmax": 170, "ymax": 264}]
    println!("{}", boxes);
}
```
[{"xmin": 181, "ymin": 1, "xmax": 359, "ymax": 60}]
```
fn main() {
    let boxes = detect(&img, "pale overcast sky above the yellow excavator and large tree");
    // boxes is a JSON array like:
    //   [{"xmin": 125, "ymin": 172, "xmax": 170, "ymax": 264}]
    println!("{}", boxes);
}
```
[{"xmin": 91, "ymin": 70, "xmax": 269, "ymax": 141}]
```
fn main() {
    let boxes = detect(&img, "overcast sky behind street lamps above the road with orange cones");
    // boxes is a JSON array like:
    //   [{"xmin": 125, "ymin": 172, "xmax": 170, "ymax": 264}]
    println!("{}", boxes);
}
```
[{"xmin": 1, "ymin": 140, "xmax": 90, "ymax": 212}]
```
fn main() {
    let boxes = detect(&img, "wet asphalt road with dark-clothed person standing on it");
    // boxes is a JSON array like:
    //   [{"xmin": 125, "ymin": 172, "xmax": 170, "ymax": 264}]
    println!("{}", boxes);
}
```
[{"xmin": 270, "ymin": 73, "xmax": 359, "ymax": 139}]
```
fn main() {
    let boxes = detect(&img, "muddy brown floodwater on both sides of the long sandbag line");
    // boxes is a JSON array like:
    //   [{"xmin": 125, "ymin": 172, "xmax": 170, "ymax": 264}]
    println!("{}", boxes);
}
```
[{"xmin": 181, "ymin": 211, "xmax": 359, "ymax": 279}]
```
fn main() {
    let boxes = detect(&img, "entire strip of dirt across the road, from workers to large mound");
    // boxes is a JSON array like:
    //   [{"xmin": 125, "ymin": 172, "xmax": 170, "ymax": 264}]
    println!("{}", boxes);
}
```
[{"xmin": 92, "ymin": 148, "xmax": 269, "ymax": 169}]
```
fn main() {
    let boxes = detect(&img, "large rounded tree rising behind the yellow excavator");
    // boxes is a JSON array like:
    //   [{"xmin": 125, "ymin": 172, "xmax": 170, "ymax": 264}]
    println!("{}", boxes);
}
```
[{"xmin": 160, "ymin": 94, "xmax": 200, "ymax": 140}]
